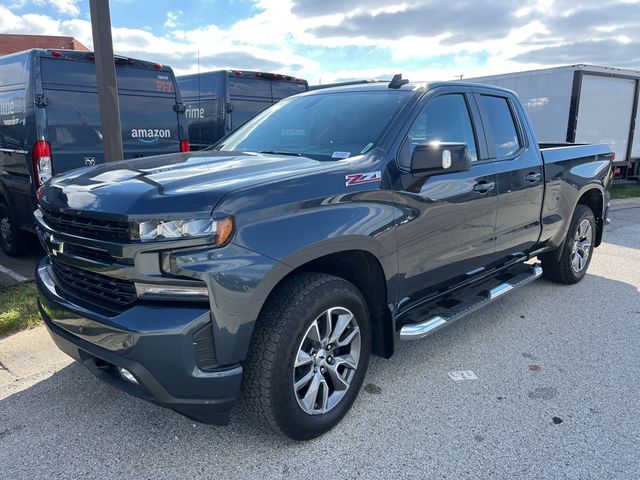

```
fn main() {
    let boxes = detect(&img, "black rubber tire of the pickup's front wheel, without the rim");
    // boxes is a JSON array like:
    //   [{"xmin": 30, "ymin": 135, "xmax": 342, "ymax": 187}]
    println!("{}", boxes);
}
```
[{"xmin": 242, "ymin": 273, "xmax": 371, "ymax": 440}]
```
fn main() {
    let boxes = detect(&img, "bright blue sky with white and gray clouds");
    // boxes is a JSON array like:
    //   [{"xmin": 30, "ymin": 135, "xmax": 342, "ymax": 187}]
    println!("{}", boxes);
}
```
[{"xmin": 0, "ymin": 0, "xmax": 640, "ymax": 83}]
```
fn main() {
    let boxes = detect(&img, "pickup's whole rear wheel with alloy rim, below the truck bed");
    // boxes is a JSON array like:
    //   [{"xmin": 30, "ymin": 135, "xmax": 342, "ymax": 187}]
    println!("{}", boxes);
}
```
[{"xmin": 542, "ymin": 205, "xmax": 596, "ymax": 285}]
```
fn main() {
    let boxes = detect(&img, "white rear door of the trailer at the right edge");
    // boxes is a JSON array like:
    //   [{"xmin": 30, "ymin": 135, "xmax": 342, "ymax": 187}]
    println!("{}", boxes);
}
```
[{"xmin": 575, "ymin": 73, "xmax": 636, "ymax": 163}]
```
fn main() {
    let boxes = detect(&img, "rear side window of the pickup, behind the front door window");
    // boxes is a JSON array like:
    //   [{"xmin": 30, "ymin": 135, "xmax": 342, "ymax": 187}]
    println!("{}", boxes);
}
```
[{"xmin": 480, "ymin": 95, "xmax": 522, "ymax": 158}]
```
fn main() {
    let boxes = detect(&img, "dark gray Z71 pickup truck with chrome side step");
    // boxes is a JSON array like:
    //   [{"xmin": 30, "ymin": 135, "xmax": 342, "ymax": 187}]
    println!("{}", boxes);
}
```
[{"xmin": 35, "ymin": 77, "xmax": 612, "ymax": 439}]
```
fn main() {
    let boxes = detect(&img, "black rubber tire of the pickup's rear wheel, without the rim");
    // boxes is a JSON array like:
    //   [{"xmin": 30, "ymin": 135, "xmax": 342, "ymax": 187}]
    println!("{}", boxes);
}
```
[{"xmin": 541, "ymin": 205, "xmax": 596, "ymax": 285}]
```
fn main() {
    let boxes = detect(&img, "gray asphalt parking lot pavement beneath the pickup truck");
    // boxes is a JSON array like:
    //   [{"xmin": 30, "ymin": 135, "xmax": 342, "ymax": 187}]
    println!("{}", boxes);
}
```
[{"xmin": 0, "ymin": 201, "xmax": 640, "ymax": 480}]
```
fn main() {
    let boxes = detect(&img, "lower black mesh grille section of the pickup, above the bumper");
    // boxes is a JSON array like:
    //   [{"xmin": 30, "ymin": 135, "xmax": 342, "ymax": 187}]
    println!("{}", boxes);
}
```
[{"xmin": 51, "ymin": 261, "xmax": 138, "ymax": 312}]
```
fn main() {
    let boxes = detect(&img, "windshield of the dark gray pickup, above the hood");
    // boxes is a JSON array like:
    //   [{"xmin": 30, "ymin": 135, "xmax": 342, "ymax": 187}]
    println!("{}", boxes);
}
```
[{"xmin": 217, "ymin": 90, "xmax": 409, "ymax": 158}]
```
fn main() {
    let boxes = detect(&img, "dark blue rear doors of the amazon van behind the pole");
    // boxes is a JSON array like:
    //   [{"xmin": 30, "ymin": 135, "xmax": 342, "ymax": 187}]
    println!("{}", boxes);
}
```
[{"xmin": 41, "ymin": 57, "xmax": 181, "ymax": 174}]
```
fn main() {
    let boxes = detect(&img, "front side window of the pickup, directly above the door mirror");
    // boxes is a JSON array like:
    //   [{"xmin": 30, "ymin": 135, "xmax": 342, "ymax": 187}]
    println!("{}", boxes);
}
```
[{"xmin": 400, "ymin": 93, "xmax": 478, "ymax": 168}]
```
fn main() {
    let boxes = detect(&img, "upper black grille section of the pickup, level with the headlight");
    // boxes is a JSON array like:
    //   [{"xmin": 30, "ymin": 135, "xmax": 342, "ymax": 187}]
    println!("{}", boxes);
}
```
[{"xmin": 41, "ymin": 208, "xmax": 130, "ymax": 242}]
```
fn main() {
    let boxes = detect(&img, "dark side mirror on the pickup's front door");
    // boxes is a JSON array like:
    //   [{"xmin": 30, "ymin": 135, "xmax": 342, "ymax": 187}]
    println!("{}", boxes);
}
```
[{"xmin": 411, "ymin": 142, "xmax": 471, "ymax": 177}]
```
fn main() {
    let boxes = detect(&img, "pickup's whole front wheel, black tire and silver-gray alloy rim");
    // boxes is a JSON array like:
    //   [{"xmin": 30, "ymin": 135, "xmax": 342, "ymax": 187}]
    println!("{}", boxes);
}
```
[{"xmin": 242, "ymin": 273, "xmax": 371, "ymax": 440}]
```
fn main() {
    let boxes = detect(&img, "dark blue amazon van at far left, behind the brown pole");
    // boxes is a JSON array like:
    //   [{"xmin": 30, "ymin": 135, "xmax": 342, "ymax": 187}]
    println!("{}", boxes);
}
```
[{"xmin": 0, "ymin": 49, "xmax": 189, "ymax": 255}]
